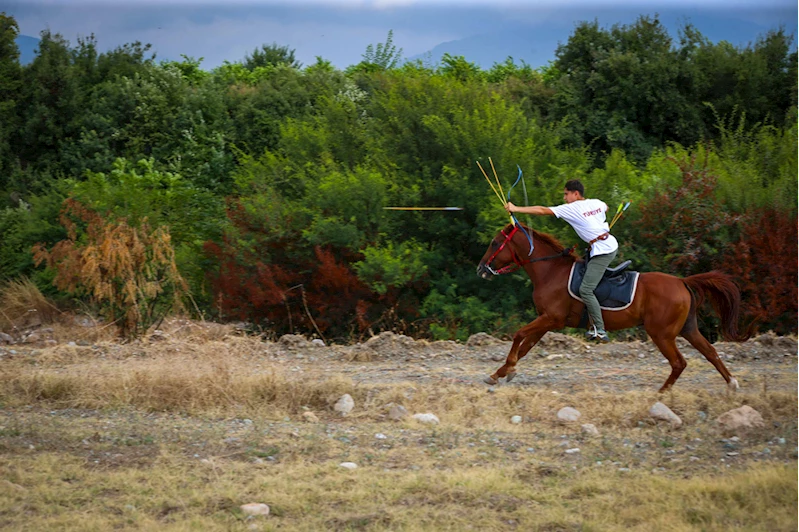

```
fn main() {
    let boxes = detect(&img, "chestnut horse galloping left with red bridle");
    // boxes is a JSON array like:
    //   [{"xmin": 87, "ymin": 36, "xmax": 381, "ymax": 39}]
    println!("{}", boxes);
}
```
[{"xmin": 477, "ymin": 225, "xmax": 751, "ymax": 392}]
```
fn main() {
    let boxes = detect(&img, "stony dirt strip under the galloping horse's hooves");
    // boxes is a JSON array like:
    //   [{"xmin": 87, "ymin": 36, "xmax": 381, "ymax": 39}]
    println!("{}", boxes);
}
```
[{"xmin": 274, "ymin": 332, "xmax": 797, "ymax": 394}]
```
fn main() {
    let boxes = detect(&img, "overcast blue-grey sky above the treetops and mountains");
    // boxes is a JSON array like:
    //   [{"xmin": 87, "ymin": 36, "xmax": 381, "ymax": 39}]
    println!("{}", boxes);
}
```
[{"xmin": 0, "ymin": 0, "xmax": 797, "ymax": 69}]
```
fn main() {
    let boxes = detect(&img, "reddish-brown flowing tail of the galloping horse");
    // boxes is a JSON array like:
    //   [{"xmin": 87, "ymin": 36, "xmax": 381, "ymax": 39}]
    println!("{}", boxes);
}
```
[{"xmin": 683, "ymin": 271, "xmax": 755, "ymax": 342}]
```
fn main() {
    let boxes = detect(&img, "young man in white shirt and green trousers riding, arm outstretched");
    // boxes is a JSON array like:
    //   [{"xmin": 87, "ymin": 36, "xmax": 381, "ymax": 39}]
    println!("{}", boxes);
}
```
[{"xmin": 505, "ymin": 179, "xmax": 619, "ymax": 342}]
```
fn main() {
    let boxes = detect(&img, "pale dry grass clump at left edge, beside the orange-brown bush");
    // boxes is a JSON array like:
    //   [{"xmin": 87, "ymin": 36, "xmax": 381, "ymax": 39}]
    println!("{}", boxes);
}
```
[{"xmin": 0, "ymin": 278, "xmax": 61, "ymax": 331}]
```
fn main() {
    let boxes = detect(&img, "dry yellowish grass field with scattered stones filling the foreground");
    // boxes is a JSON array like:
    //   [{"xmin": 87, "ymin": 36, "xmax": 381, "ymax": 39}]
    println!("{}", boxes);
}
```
[{"xmin": 0, "ymin": 320, "xmax": 797, "ymax": 532}]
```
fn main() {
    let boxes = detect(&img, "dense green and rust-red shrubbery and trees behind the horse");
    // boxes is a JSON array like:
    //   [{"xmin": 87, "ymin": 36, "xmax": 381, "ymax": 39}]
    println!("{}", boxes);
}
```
[{"xmin": 0, "ymin": 15, "xmax": 797, "ymax": 339}]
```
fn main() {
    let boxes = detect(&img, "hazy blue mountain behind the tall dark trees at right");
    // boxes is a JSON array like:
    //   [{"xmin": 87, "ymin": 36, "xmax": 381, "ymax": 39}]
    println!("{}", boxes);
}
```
[{"xmin": 408, "ymin": 10, "xmax": 796, "ymax": 69}]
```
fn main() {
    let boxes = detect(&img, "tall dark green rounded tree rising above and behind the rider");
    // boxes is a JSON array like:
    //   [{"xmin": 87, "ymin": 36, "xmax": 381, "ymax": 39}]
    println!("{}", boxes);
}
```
[{"xmin": 553, "ymin": 16, "xmax": 702, "ymax": 163}]
